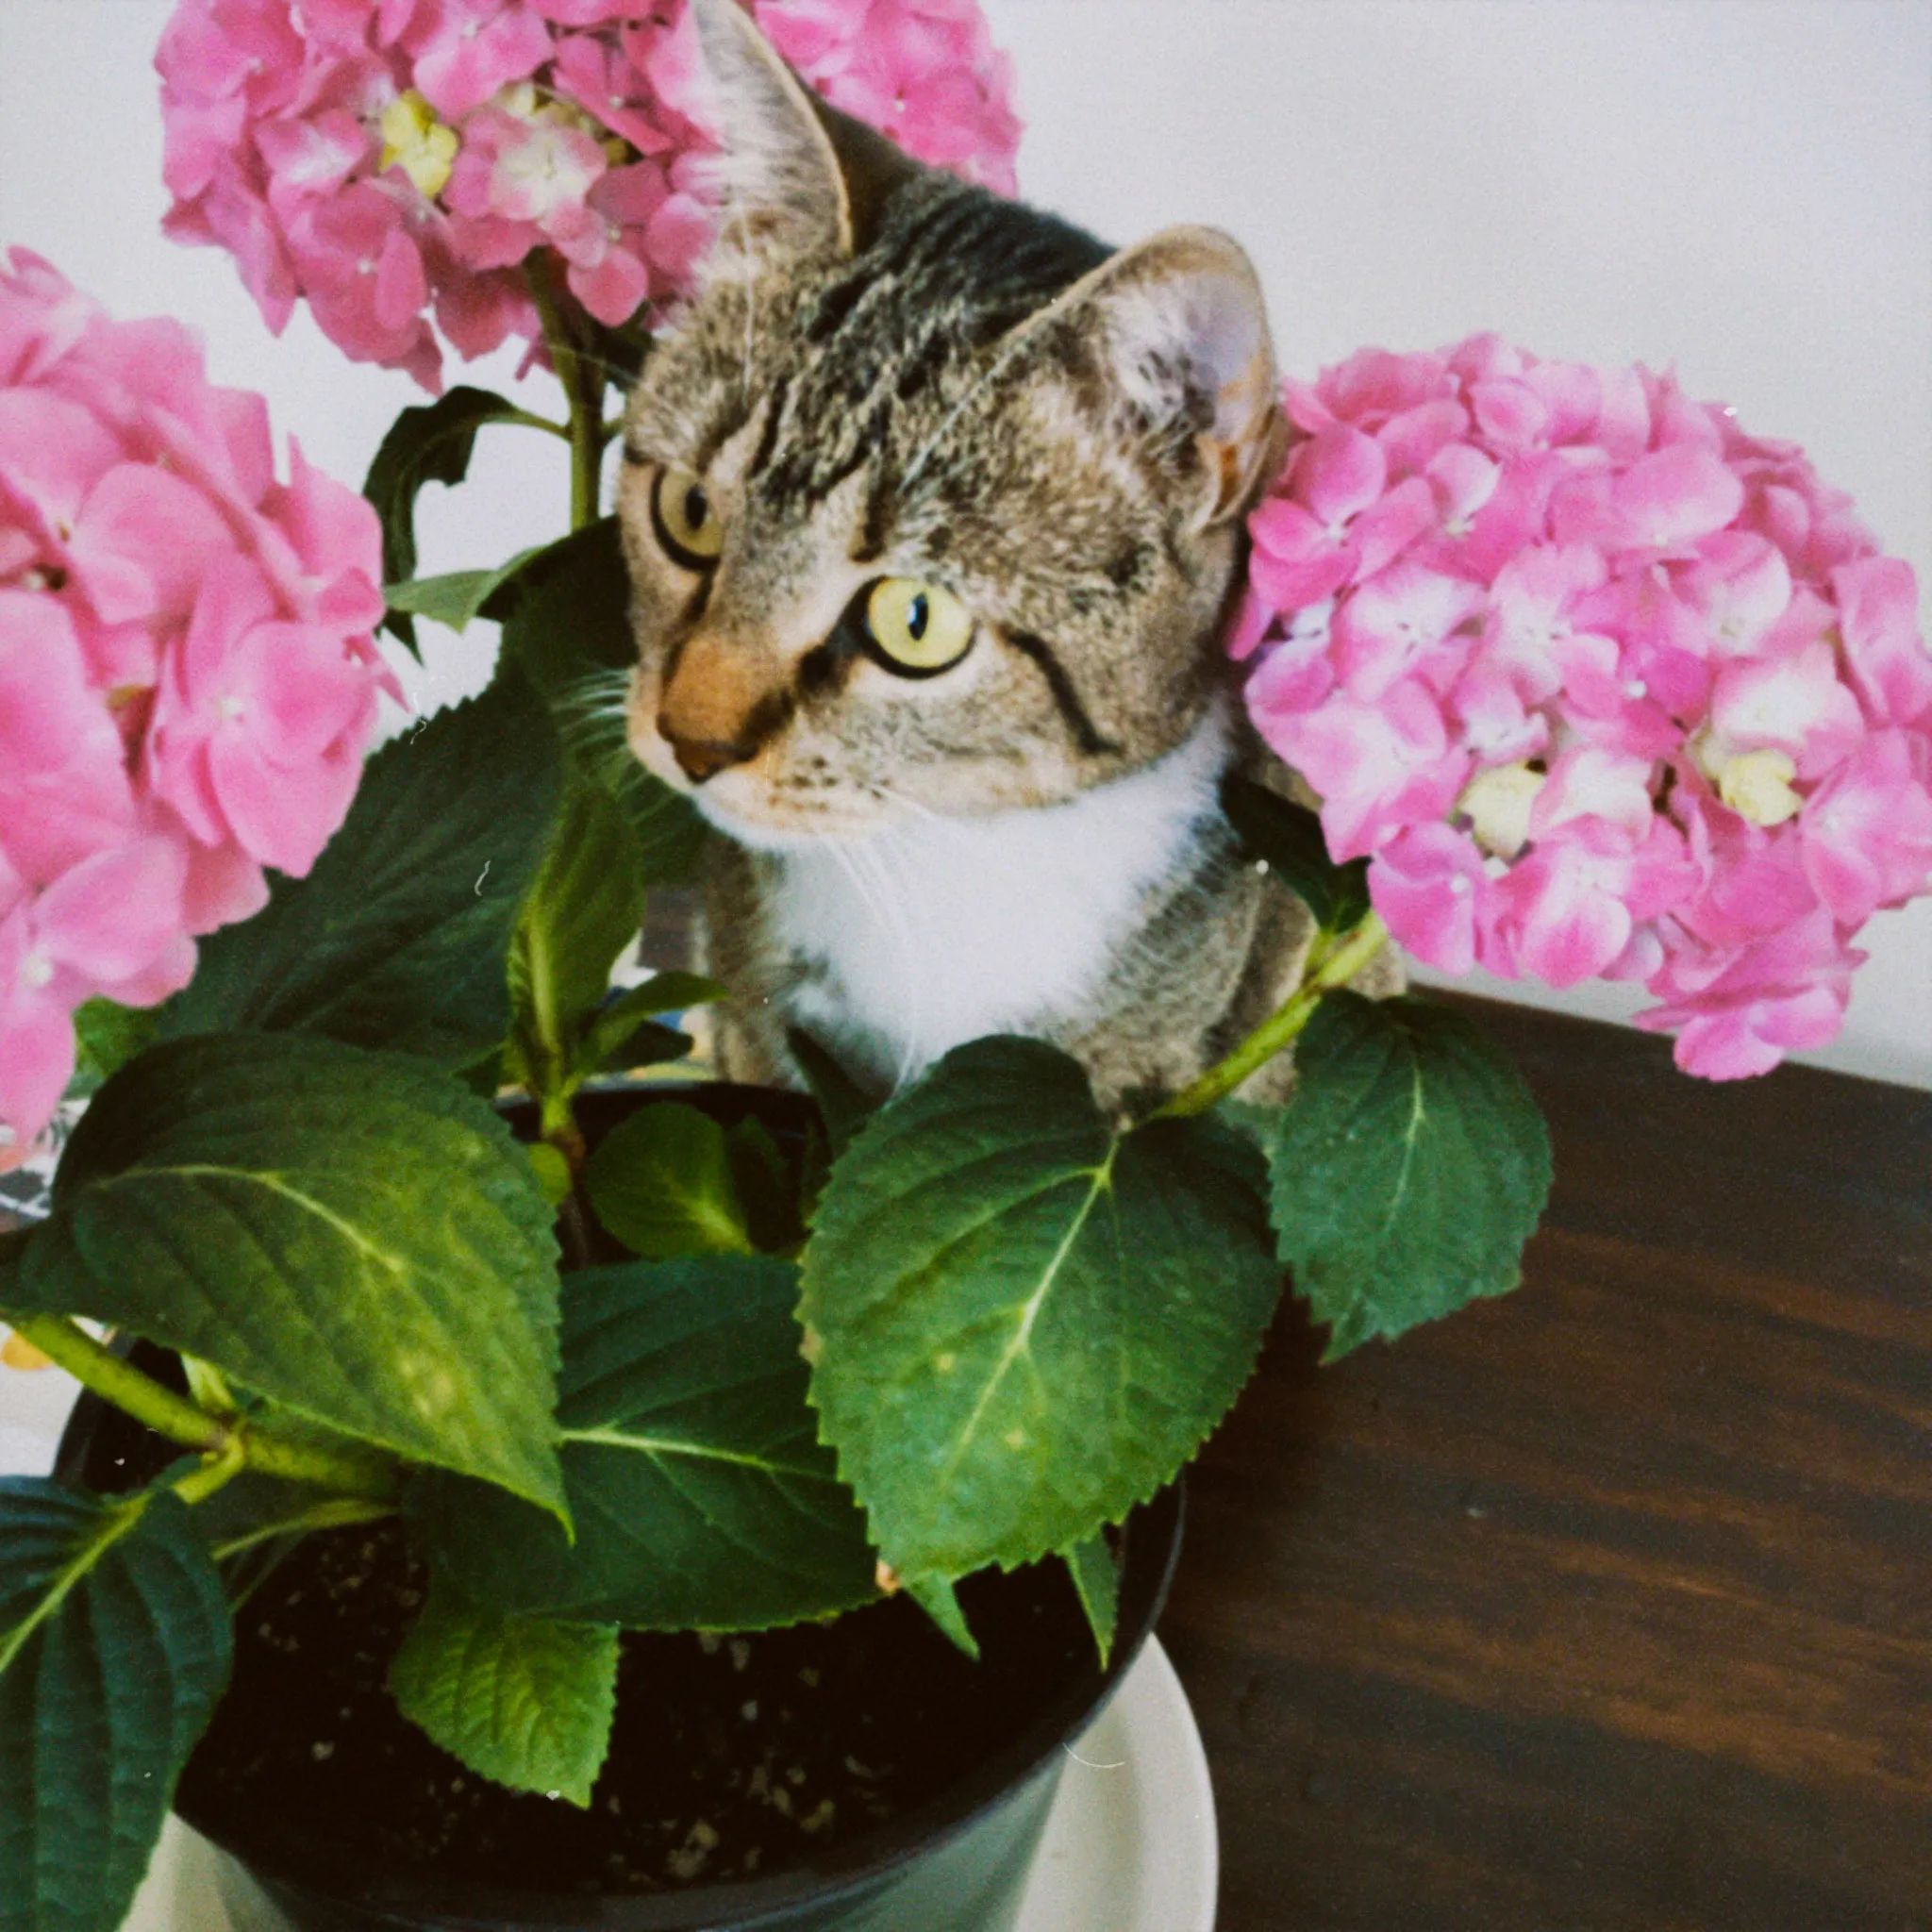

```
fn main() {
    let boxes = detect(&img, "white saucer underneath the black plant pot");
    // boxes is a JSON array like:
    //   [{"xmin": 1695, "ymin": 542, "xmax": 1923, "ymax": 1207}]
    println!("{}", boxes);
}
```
[{"xmin": 0, "ymin": 1368, "xmax": 1219, "ymax": 1932}]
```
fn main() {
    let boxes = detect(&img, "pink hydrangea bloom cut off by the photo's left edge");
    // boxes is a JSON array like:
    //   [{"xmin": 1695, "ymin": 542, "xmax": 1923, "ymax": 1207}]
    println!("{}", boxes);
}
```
[{"xmin": 0, "ymin": 249, "xmax": 394, "ymax": 1169}]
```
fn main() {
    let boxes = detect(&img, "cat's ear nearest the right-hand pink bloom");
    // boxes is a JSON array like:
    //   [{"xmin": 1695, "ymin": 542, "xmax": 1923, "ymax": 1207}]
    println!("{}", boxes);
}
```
[{"xmin": 1025, "ymin": 228, "xmax": 1287, "ymax": 529}]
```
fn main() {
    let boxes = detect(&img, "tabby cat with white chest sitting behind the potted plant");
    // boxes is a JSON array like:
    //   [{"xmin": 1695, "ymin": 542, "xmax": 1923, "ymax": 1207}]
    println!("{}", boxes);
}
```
[{"xmin": 620, "ymin": 0, "xmax": 1391, "ymax": 1105}]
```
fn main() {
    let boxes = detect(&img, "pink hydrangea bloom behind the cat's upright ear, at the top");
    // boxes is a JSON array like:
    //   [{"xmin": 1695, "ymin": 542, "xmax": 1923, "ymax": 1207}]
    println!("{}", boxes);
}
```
[{"xmin": 155, "ymin": 0, "xmax": 1020, "ymax": 391}]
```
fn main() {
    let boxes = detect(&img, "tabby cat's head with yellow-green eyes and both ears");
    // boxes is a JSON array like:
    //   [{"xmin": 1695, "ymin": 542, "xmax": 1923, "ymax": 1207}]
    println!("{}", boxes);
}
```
[{"xmin": 618, "ymin": 0, "xmax": 1281, "ymax": 846}]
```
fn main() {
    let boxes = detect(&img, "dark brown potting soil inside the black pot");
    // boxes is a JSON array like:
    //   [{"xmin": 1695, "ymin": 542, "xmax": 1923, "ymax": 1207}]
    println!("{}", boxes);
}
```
[{"xmin": 179, "ymin": 1524, "xmax": 1095, "ymax": 1891}]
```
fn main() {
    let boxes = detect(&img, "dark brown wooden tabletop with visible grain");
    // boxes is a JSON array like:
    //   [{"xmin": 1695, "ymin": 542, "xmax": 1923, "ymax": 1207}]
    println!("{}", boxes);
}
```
[{"xmin": 1161, "ymin": 1001, "xmax": 1932, "ymax": 1932}]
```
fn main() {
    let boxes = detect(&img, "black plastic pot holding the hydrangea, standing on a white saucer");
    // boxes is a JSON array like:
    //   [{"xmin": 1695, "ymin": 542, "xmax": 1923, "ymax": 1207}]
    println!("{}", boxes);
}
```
[{"xmin": 56, "ymin": 1090, "xmax": 1182, "ymax": 1932}]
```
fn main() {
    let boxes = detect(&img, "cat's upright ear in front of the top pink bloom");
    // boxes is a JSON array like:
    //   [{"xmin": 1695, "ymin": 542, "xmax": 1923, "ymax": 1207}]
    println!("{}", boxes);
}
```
[{"xmin": 676, "ymin": 0, "xmax": 918, "ymax": 282}]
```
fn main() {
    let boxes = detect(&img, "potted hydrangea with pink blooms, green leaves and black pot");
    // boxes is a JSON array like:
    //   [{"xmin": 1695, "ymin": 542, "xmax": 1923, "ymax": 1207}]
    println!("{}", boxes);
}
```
[{"xmin": 0, "ymin": 0, "xmax": 1932, "ymax": 1932}]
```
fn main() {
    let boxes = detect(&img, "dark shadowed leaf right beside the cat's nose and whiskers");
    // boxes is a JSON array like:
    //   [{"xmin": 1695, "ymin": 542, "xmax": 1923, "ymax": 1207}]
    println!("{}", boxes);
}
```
[{"xmin": 485, "ymin": 518, "xmax": 706, "ymax": 887}]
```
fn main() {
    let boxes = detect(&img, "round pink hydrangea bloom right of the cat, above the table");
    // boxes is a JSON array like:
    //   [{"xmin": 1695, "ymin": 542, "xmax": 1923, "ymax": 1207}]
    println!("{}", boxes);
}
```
[{"xmin": 1231, "ymin": 336, "xmax": 1932, "ymax": 1080}]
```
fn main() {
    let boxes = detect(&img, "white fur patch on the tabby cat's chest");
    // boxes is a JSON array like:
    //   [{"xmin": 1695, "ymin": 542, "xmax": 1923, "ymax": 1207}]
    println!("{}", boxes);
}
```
[{"xmin": 771, "ymin": 715, "xmax": 1226, "ymax": 1084}]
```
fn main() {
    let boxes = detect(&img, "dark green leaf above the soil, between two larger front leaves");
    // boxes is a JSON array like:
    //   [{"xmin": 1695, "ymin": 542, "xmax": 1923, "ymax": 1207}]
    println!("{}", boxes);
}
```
[{"xmin": 419, "ymin": 1267, "xmax": 877, "ymax": 1631}]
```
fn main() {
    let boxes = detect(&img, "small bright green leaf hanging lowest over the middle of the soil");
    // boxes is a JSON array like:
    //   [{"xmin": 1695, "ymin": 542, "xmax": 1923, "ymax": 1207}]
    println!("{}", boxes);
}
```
[{"xmin": 389, "ymin": 1576, "xmax": 618, "ymax": 1808}]
